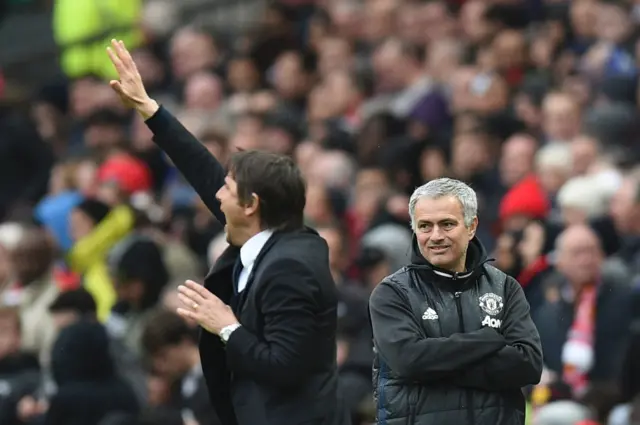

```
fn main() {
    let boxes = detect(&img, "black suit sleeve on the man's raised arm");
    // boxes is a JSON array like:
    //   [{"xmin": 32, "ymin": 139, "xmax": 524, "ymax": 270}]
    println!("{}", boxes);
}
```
[{"xmin": 145, "ymin": 106, "xmax": 226, "ymax": 224}]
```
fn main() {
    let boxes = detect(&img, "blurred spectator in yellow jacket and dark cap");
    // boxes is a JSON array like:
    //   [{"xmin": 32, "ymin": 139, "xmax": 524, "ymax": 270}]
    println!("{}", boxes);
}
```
[{"xmin": 67, "ymin": 199, "xmax": 134, "ymax": 321}]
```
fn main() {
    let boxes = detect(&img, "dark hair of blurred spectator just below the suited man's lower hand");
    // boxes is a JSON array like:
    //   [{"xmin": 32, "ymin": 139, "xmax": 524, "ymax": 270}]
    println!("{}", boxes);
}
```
[{"xmin": 141, "ymin": 308, "xmax": 193, "ymax": 356}]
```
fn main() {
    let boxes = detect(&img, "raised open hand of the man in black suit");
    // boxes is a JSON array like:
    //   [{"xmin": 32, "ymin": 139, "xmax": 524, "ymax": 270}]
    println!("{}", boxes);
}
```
[{"xmin": 107, "ymin": 39, "xmax": 159, "ymax": 119}]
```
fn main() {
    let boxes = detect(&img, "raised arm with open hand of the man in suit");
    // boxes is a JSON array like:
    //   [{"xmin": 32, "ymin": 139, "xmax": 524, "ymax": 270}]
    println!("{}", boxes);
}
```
[{"xmin": 107, "ymin": 40, "xmax": 226, "ymax": 224}]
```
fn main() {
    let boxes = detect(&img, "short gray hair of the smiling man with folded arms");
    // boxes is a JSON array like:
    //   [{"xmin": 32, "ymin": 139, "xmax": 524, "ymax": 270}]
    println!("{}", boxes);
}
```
[{"xmin": 409, "ymin": 178, "xmax": 478, "ymax": 231}]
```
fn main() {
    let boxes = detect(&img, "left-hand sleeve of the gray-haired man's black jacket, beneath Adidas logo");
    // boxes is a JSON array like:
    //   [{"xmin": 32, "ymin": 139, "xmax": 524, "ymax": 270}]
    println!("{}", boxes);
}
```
[{"xmin": 369, "ymin": 282, "xmax": 505, "ymax": 382}]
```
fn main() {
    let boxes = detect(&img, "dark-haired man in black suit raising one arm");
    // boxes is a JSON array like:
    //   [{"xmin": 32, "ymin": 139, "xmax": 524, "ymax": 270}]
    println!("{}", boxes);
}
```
[{"xmin": 108, "ymin": 40, "xmax": 346, "ymax": 425}]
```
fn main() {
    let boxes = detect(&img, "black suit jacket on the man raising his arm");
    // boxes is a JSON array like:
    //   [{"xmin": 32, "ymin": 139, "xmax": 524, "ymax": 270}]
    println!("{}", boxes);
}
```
[{"xmin": 147, "ymin": 108, "xmax": 348, "ymax": 425}]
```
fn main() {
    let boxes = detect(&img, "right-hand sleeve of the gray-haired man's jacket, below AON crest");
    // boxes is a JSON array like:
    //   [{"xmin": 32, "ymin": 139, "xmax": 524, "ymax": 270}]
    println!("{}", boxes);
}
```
[{"xmin": 454, "ymin": 278, "xmax": 542, "ymax": 391}]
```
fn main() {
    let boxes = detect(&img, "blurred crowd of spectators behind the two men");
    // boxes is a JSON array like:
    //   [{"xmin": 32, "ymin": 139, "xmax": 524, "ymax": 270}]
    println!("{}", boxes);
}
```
[{"xmin": 0, "ymin": 0, "xmax": 640, "ymax": 425}]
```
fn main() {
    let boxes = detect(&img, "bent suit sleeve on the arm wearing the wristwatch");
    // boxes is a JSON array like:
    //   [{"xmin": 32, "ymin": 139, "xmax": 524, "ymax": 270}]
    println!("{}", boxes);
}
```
[{"xmin": 226, "ymin": 259, "xmax": 324, "ymax": 387}]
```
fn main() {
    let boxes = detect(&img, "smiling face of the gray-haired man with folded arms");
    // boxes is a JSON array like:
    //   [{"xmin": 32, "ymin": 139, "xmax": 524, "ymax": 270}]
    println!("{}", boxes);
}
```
[{"xmin": 415, "ymin": 196, "xmax": 478, "ymax": 272}]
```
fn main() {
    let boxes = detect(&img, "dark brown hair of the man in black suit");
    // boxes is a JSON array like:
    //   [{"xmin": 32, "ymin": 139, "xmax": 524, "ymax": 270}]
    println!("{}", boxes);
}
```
[{"xmin": 229, "ymin": 151, "xmax": 306, "ymax": 230}]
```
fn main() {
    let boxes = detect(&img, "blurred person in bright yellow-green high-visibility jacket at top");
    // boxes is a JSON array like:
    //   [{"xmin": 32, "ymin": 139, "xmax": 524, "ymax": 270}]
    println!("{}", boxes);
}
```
[{"xmin": 53, "ymin": 0, "xmax": 143, "ymax": 80}]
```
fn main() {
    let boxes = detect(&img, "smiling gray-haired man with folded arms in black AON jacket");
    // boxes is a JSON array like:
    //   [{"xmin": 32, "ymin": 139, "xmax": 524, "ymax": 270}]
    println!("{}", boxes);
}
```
[{"xmin": 369, "ymin": 178, "xmax": 542, "ymax": 425}]
